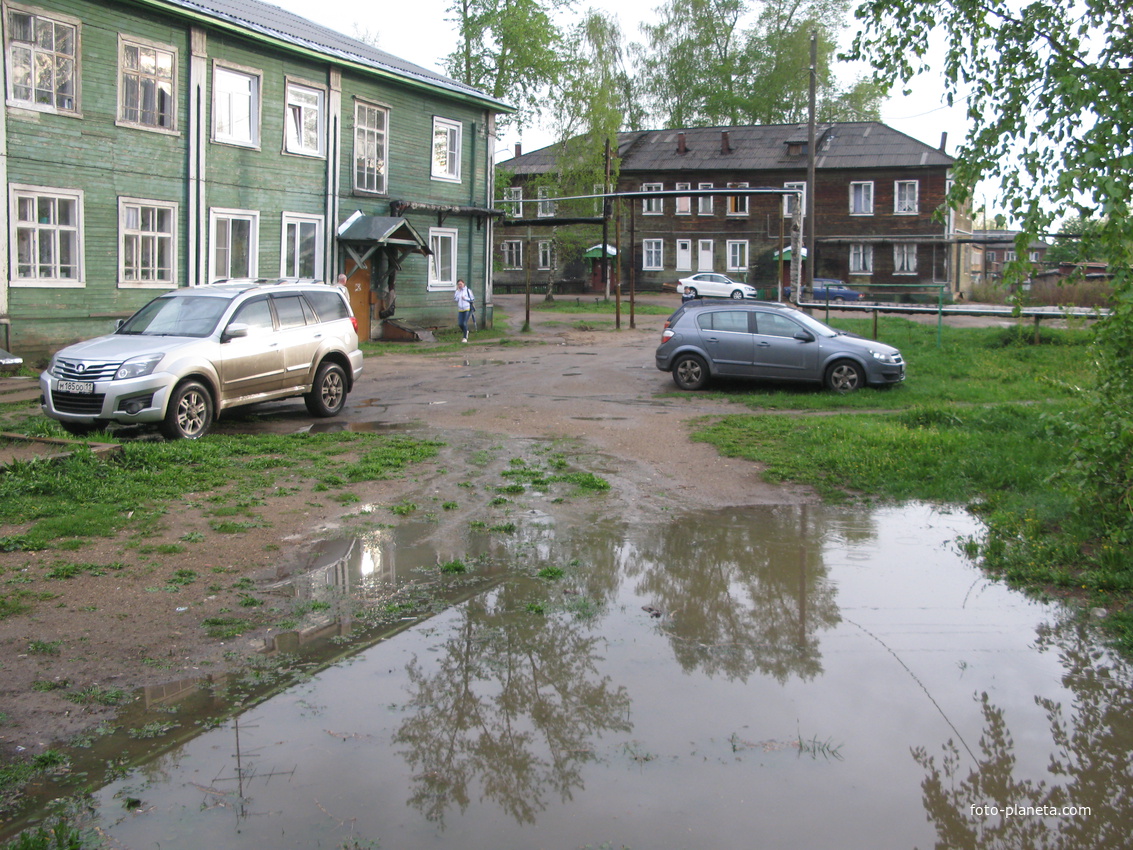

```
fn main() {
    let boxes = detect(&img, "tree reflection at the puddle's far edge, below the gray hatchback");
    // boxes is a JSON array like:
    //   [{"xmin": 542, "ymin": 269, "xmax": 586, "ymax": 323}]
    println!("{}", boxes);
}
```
[{"xmin": 628, "ymin": 507, "xmax": 840, "ymax": 681}]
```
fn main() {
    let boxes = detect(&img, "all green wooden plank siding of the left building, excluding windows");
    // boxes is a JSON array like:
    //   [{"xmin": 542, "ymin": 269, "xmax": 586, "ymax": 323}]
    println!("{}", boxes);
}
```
[{"xmin": 3, "ymin": 0, "xmax": 492, "ymax": 362}]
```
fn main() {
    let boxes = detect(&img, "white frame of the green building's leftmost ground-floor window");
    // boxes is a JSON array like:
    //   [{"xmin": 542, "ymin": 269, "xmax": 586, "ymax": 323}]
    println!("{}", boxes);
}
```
[{"xmin": 8, "ymin": 184, "xmax": 86, "ymax": 289}]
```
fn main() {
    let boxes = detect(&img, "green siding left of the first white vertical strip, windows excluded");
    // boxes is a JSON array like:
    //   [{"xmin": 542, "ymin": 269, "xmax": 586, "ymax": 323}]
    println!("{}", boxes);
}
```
[{"xmin": 3, "ymin": 0, "xmax": 189, "ymax": 352}]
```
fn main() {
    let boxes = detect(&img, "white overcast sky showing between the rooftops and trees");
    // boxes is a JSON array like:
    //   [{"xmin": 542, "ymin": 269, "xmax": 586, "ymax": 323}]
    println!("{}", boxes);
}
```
[{"xmin": 269, "ymin": 0, "xmax": 990, "ymax": 201}]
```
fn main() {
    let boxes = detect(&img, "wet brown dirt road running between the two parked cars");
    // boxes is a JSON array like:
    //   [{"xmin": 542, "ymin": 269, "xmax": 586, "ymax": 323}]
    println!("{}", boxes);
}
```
[{"xmin": 0, "ymin": 295, "xmax": 813, "ymax": 754}]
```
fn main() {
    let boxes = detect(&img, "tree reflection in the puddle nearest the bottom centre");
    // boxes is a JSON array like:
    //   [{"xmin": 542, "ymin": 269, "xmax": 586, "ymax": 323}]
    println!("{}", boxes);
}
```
[{"xmin": 393, "ymin": 585, "xmax": 630, "ymax": 823}]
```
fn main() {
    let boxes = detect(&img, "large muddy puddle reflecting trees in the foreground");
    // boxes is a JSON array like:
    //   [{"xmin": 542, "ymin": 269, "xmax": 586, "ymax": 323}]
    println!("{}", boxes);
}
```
[{"xmin": 82, "ymin": 505, "xmax": 1133, "ymax": 850}]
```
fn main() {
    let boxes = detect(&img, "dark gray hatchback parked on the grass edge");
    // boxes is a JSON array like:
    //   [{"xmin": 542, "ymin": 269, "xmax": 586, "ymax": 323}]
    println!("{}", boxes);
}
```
[{"xmin": 657, "ymin": 301, "xmax": 905, "ymax": 392}]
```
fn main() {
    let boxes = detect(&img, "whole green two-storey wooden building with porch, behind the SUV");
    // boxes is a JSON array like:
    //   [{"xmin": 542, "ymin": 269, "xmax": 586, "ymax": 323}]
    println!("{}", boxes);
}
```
[{"xmin": 0, "ymin": 0, "xmax": 510, "ymax": 357}]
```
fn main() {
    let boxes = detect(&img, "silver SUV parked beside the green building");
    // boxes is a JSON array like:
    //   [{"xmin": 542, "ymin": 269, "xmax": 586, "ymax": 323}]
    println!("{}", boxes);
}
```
[{"xmin": 40, "ymin": 280, "xmax": 363, "ymax": 440}]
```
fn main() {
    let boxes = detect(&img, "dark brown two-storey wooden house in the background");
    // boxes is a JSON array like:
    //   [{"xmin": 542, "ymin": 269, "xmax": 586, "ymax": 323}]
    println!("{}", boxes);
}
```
[{"xmin": 493, "ymin": 121, "xmax": 968, "ymax": 298}]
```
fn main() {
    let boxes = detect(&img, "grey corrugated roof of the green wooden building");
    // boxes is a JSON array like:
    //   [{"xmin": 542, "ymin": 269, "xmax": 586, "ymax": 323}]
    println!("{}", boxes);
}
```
[{"xmin": 144, "ymin": 0, "xmax": 514, "ymax": 112}]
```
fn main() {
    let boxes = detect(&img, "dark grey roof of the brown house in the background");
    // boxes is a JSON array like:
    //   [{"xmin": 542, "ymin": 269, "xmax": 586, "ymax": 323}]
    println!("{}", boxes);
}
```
[{"xmin": 499, "ymin": 121, "xmax": 955, "ymax": 175}]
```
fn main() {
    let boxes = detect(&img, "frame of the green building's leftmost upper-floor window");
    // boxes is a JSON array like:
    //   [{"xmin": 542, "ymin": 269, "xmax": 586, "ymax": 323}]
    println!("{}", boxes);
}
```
[{"xmin": 3, "ymin": 3, "xmax": 83, "ymax": 117}]
